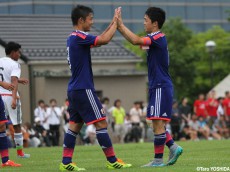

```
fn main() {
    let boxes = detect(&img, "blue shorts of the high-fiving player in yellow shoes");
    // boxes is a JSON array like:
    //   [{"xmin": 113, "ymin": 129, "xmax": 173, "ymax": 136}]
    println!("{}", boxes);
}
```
[{"xmin": 68, "ymin": 89, "xmax": 106, "ymax": 125}]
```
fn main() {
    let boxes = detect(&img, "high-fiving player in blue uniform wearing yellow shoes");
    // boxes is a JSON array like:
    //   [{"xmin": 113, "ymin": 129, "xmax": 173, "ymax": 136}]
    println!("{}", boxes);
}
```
[{"xmin": 59, "ymin": 5, "xmax": 131, "ymax": 171}]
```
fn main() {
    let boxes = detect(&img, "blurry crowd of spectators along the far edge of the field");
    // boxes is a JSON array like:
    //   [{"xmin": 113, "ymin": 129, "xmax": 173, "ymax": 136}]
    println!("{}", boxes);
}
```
[{"xmin": 4, "ymin": 88, "xmax": 230, "ymax": 147}]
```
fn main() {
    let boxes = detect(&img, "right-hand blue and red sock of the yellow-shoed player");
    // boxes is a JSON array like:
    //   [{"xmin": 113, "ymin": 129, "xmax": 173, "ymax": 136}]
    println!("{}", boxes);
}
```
[{"xmin": 96, "ymin": 128, "xmax": 117, "ymax": 163}]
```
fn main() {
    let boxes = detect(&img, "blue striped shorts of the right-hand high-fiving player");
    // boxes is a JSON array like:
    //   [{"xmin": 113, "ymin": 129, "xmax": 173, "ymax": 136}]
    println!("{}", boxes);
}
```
[{"xmin": 146, "ymin": 87, "xmax": 173, "ymax": 121}]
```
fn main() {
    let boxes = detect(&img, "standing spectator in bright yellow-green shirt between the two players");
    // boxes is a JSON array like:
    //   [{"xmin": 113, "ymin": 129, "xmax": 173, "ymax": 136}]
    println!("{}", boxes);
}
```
[{"xmin": 112, "ymin": 99, "xmax": 126, "ymax": 143}]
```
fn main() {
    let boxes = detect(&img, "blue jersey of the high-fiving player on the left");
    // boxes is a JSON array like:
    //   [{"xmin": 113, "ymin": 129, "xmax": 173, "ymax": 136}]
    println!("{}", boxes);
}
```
[{"xmin": 67, "ymin": 31, "xmax": 97, "ymax": 91}]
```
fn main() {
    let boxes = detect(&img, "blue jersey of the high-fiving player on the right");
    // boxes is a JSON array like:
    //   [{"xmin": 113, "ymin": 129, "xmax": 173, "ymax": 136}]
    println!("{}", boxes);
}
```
[{"xmin": 146, "ymin": 31, "xmax": 173, "ymax": 89}]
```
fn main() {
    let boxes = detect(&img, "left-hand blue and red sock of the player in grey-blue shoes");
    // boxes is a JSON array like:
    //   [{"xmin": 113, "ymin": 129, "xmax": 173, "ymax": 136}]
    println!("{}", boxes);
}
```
[{"xmin": 154, "ymin": 133, "xmax": 166, "ymax": 159}]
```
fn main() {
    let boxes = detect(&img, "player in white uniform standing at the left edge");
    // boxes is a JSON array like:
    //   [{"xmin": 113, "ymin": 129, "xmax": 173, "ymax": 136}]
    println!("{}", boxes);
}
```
[{"xmin": 0, "ymin": 42, "xmax": 30, "ymax": 158}]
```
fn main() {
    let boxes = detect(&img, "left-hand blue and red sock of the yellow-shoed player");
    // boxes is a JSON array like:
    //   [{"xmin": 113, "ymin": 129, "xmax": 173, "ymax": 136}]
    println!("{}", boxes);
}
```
[{"xmin": 62, "ymin": 129, "xmax": 78, "ymax": 165}]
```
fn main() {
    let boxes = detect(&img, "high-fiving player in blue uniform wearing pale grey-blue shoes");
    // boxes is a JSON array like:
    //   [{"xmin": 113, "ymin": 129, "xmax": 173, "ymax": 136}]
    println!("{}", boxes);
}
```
[{"xmin": 118, "ymin": 7, "xmax": 183, "ymax": 167}]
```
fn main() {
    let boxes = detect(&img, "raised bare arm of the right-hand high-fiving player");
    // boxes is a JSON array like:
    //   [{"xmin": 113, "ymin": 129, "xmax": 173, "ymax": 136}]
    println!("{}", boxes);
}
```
[{"xmin": 118, "ymin": 7, "xmax": 146, "ymax": 45}]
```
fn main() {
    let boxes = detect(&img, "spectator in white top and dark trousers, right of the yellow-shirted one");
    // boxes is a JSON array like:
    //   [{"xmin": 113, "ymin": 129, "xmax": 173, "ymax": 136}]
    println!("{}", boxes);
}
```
[{"xmin": 129, "ymin": 102, "xmax": 143, "ymax": 142}]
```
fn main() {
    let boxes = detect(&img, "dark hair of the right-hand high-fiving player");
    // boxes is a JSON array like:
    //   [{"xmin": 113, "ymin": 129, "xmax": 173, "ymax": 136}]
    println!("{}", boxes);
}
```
[{"xmin": 145, "ymin": 7, "xmax": 165, "ymax": 29}]
